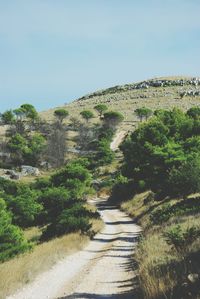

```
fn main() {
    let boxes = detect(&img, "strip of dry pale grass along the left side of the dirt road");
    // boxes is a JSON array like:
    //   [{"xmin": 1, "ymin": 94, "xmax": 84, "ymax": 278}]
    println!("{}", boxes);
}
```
[{"xmin": 0, "ymin": 205, "xmax": 104, "ymax": 299}]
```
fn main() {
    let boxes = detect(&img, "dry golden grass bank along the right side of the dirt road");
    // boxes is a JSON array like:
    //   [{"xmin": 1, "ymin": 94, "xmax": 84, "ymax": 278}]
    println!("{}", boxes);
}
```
[{"xmin": 122, "ymin": 191, "xmax": 200, "ymax": 299}]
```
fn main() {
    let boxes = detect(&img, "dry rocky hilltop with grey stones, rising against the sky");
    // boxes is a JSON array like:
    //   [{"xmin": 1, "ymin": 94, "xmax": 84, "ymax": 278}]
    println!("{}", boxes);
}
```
[{"xmin": 41, "ymin": 77, "xmax": 200, "ymax": 130}]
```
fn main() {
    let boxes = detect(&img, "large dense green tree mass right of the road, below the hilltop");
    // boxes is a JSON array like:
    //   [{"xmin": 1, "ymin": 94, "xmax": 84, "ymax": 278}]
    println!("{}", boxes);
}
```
[{"xmin": 121, "ymin": 109, "xmax": 200, "ymax": 196}]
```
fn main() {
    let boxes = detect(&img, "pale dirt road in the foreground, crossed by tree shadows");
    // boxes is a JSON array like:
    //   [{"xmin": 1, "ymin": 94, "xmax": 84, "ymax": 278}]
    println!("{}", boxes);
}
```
[{"xmin": 8, "ymin": 200, "xmax": 140, "ymax": 299}]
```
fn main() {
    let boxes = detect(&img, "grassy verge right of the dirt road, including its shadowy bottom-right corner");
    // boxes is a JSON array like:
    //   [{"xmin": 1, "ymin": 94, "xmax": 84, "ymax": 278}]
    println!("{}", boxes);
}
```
[{"xmin": 121, "ymin": 191, "xmax": 200, "ymax": 299}]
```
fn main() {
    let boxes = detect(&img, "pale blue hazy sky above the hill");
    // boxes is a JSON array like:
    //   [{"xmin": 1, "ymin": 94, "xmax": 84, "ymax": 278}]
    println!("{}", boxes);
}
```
[{"xmin": 0, "ymin": 0, "xmax": 200, "ymax": 112}]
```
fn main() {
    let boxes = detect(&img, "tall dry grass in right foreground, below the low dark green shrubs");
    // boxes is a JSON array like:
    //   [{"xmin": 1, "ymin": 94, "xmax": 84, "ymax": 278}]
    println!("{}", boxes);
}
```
[{"xmin": 136, "ymin": 215, "xmax": 200, "ymax": 299}]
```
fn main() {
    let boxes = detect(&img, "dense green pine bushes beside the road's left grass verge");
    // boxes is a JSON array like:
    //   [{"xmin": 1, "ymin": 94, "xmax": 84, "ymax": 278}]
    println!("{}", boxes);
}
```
[{"xmin": 0, "ymin": 159, "xmax": 98, "ymax": 261}]
